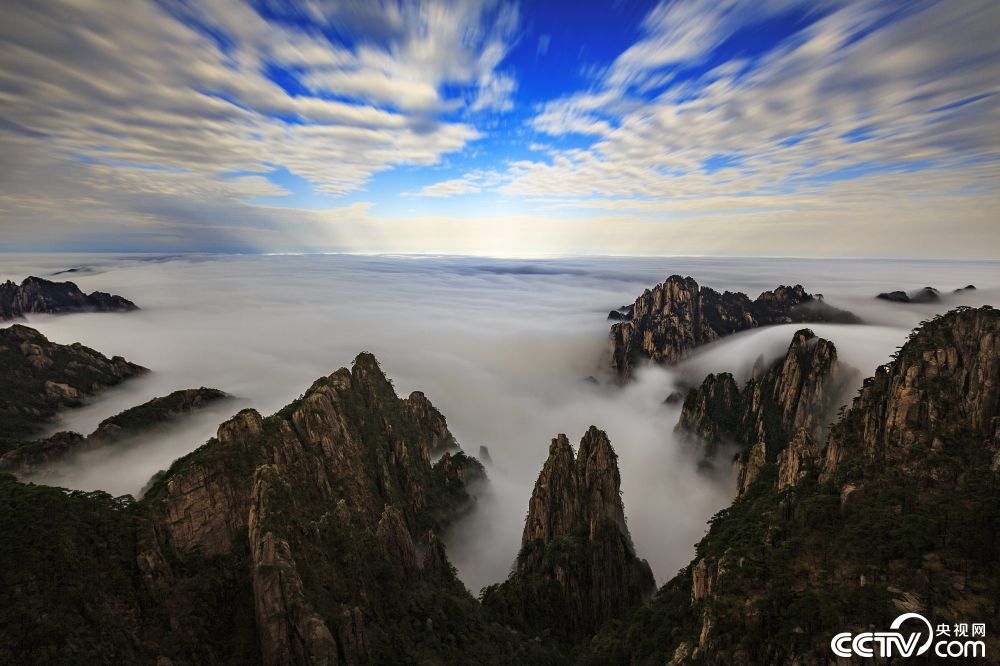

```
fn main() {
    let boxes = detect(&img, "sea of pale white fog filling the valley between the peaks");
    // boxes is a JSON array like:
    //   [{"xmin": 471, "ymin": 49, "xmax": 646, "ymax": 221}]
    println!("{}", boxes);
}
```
[{"xmin": 0, "ymin": 255, "xmax": 1000, "ymax": 592}]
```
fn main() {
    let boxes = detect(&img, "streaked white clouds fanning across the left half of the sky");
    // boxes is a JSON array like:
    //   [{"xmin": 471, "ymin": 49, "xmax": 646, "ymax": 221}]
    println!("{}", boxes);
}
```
[{"xmin": 0, "ymin": 0, "xmax": 518, "ymax": 225}]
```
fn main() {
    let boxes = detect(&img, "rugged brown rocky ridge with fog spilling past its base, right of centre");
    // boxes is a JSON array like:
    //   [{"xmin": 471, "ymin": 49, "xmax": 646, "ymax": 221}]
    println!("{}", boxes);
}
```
[{"xmin": 611, "ymin": 275, "xmax": 860, "ymax": 381}]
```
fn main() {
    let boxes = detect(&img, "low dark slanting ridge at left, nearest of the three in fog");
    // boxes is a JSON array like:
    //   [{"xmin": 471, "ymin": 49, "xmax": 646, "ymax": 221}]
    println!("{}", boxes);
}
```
[{"xmin": 0, "ymin": 387, "xmax": 228, "ymax": 477}]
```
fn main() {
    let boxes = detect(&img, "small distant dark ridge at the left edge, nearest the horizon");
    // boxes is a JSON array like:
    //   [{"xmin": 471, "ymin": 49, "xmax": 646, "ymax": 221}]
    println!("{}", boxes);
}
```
[{"xmin": 0, "ymin": 277, "xmax": 139, "ymax": 320}]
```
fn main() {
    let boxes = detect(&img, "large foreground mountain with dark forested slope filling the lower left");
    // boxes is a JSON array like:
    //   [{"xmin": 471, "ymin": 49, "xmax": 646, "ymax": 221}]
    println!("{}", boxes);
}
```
[{"xmin": 0, "ymin": 354, "xmax": 553, "ymax": 665}]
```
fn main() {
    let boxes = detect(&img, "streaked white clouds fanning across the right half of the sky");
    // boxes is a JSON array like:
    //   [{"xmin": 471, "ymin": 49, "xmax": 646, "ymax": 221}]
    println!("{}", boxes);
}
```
[{"xmin": 499, "ymin": 2, "xmax": 1000, "ymax": 232}]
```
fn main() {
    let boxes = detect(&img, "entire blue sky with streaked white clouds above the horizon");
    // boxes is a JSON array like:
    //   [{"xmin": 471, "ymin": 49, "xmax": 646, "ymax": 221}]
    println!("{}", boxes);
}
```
[{"xmin": 0, "ymin": 0, "xmax": 1000, "ymax": 258}]
